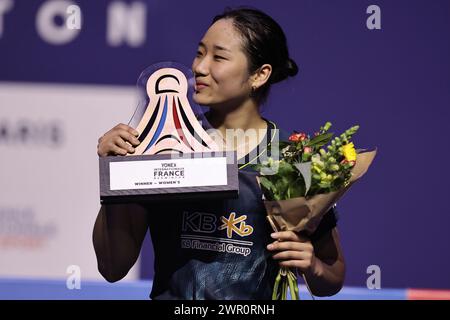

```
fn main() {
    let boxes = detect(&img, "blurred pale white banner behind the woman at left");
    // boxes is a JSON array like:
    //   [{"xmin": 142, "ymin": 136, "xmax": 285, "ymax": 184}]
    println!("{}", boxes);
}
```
[{"xmin": 0, "ymin": 83, "xmax": 138, "ymax": 279}]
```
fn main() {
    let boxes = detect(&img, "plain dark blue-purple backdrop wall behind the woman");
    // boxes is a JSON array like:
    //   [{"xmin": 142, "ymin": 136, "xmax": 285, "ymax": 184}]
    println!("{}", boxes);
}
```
[{"xmin": 0, "ymin": 0, "xmax": 450, "ymax": 288}]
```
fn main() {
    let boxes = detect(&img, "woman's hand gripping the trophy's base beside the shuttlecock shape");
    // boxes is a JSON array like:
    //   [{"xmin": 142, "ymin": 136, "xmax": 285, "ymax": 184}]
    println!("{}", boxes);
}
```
[{"xmin": 97, "ymin": 123, "xmax": 140, "ymax": 157}]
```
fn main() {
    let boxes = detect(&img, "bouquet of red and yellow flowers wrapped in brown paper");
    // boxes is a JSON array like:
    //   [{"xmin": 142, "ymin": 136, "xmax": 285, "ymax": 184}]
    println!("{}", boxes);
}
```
[{"xmin": 254, "ymin": 122, "xmax": 376, "ymax": 300}]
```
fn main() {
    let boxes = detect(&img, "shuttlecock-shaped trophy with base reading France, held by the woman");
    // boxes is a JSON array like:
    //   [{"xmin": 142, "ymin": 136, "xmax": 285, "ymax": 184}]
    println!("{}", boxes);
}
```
[{"xmin": 99, "ymin": 62, "xmax": 239, "ymax": 203}]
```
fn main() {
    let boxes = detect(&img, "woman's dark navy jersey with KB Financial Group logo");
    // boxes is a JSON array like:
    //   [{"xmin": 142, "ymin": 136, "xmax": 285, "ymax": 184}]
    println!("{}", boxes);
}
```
[{"xmin": 148, "ymin": 122, "xmax": 337, "ymax": 300}]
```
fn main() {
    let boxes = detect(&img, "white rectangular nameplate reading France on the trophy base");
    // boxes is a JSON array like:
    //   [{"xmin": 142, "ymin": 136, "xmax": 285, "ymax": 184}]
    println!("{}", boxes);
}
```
[{"xmin": 109, "ymin": 157, "xmax": 227, "ymax": 190}]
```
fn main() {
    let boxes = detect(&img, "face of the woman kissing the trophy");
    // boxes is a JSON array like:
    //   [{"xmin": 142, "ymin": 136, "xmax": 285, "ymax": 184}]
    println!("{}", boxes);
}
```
[{"xmin": 192, "ymin": 19, "xmax": 251, "ymax": 108}]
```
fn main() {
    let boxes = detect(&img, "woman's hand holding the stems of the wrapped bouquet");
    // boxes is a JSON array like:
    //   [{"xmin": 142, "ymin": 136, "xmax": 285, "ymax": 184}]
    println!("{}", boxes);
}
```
[{"xmin": 267, "ymin": 231, "xmax": 317, "ymax": 273}]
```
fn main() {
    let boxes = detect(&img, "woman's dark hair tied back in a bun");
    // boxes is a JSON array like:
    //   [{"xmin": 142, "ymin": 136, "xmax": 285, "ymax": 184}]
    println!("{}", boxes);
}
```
[{"xmin": 212, "ymin": 7, "xmax": 298, "ymax": 103}]
